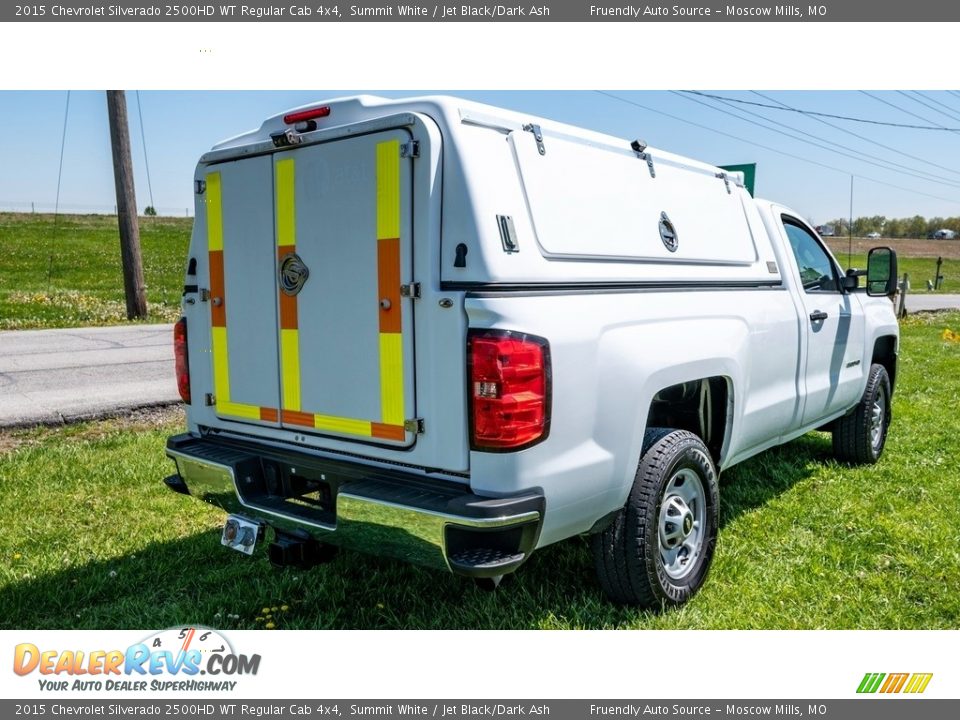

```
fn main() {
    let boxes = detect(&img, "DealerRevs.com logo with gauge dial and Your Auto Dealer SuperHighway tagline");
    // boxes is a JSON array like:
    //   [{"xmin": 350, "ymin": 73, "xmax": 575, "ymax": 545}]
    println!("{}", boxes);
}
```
[{"xmin": 13, "ymin": 627, "xmax": 260, "ymax": 692}]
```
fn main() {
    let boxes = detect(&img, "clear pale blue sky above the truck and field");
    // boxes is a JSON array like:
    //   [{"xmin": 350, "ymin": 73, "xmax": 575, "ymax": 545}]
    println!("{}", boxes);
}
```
[{"xmin": 0, "ymin": 90, "xmax": 960, "ymax": 223}]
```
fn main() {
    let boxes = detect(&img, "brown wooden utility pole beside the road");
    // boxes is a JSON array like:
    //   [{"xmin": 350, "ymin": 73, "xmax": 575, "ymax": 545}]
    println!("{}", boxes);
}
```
[{"xmin": 107, "ymin": 90, "xmax": 147, "ymax": 320}]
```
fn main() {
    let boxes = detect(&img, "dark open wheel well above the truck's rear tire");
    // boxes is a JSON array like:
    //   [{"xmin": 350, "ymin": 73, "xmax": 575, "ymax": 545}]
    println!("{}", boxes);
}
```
[{"xmin": 647, "ymin": 376, "xmax": 728, "ymax": 465}]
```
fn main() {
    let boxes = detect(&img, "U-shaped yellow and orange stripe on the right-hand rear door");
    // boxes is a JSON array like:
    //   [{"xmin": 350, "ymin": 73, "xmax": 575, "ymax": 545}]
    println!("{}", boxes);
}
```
[{"xmin": 274, "ymin": 140, "xmax": 406, "ymax": 442}]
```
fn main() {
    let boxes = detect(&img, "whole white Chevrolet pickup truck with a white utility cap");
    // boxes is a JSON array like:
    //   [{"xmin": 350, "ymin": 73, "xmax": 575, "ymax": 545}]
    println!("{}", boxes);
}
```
[{"xmin": 167, "ymin": 97, "xmax": 898, "ymax": 607}]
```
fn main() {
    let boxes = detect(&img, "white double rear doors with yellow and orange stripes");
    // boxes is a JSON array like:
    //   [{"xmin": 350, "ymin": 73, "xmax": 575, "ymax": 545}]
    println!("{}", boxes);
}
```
[{"xmin": 206, "ymin": 129, "xmax": 415, "ymax": 447}]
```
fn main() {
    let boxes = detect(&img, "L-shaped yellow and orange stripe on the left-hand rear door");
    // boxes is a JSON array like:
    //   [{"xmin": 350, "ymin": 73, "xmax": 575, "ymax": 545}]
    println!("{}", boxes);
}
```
[{"xmin": 206, "ymin": 172, "xmax": 277, "ymax": 422}]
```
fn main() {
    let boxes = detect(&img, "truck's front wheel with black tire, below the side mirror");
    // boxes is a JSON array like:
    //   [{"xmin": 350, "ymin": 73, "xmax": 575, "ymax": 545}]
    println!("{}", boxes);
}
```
[{"xmin": 833, "ymin": 364, "xmax": 892, "ymax": 465}]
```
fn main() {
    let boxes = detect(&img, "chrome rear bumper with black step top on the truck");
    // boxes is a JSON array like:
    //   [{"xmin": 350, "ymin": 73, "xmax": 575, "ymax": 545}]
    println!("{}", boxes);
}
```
[{"xmin": 167, "ymin": 435, "xmax": 544, "ymax": 577}]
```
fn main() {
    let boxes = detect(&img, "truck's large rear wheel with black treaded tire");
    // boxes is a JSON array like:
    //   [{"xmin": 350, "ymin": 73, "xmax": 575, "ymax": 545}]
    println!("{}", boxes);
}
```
[{"xmin": 591, "ymin": 428, "xmax": 720, "ymax": 608}]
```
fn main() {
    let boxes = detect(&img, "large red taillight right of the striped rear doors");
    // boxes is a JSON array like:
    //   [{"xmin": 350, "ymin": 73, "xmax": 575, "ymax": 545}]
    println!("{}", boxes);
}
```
[{"xmin": 467, "ymin": 330, "xmax": 550, "ymax": 451}]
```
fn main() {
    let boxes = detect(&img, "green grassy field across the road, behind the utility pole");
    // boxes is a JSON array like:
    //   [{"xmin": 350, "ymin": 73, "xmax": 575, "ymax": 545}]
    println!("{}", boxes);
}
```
[{"xmin": 0, "ymin": 213, "xmax": 193, "ymax": 330}]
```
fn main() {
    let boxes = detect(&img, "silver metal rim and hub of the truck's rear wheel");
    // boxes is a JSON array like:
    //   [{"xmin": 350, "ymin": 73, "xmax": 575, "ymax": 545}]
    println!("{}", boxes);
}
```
[{"xmin": 657, "ymin": 469, "xmax": 706, "ymax": 580}]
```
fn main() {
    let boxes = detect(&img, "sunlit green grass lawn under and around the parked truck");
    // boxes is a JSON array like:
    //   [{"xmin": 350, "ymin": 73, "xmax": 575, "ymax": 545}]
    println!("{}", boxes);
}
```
[{"xmin": 0, "ymin": 313, "xmax": 960, "ymax": 629}]
